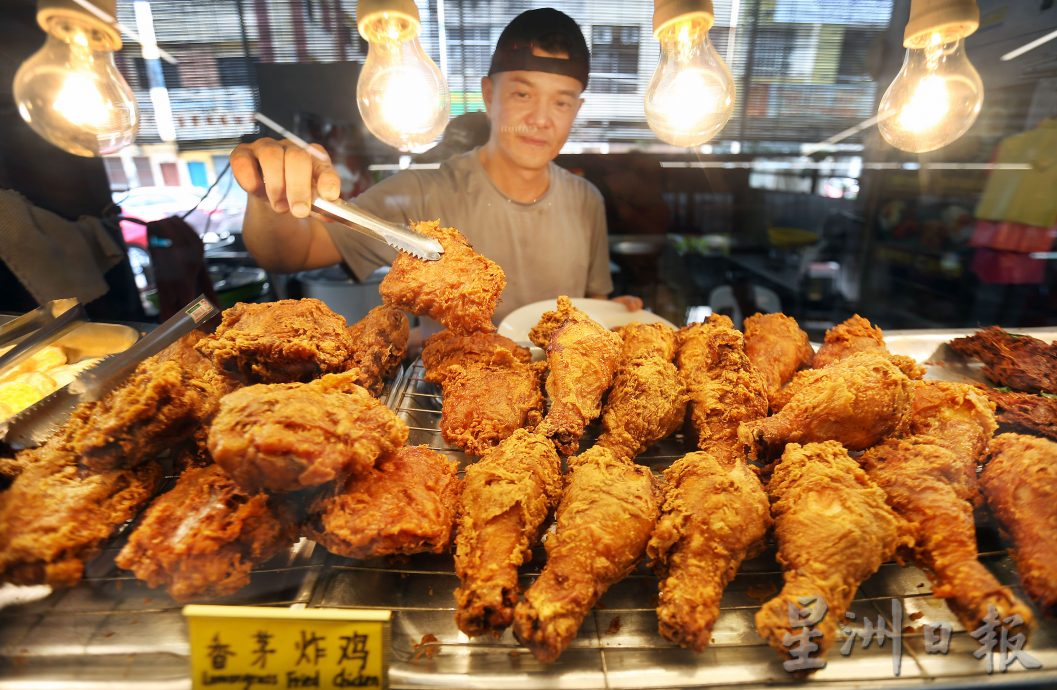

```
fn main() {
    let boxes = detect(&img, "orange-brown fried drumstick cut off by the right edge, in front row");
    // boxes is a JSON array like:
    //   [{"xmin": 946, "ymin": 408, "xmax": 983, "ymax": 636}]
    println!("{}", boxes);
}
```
[{"xmin": 980, "ymin": 433, "xmax": 1057, "ymax": 616}]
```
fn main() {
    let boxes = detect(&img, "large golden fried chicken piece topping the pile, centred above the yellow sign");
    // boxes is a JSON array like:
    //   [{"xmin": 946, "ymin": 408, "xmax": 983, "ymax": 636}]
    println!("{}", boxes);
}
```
[{"xmin": 208, "ymin": 371, "xmax": 408, "ymax": 493}]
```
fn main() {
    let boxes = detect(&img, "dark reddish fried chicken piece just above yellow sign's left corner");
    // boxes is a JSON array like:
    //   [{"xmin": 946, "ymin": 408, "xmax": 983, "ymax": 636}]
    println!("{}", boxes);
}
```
[{"xmin": 114, "ymin": 465, "xmax": 297, "ymax": 602}]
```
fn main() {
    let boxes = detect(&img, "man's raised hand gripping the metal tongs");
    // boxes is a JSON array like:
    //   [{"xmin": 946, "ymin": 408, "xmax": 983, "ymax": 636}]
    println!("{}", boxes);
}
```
[{"xmin": 231, "ymin": 137, "xmax": 341, "ymax": 218}]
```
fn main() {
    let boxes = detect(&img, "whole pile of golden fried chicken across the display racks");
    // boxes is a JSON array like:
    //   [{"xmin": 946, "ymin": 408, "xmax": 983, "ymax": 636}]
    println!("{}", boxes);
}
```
[{"xmin": 0, "ymin": 223, "xmax": 1057, "ymax": 663}]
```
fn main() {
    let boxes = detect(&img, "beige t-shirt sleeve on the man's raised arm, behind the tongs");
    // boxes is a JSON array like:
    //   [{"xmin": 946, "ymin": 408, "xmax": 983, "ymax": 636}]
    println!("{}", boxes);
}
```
[{"xmin": 327, "ymin": 171, "xmax": 425, "ymax": 280}]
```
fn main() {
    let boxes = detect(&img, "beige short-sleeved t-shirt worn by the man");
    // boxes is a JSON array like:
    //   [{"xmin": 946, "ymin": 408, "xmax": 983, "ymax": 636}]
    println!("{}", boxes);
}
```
[{"xmin": 328, "ymin": 149, "xmax": 613, "ymax": 321}]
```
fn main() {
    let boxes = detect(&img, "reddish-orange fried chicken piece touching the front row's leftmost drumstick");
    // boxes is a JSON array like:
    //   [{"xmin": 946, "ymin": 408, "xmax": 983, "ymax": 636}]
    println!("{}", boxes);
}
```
[{"xmin": 304, "ymin": 446, "xmax": 462, "ymax": 558}]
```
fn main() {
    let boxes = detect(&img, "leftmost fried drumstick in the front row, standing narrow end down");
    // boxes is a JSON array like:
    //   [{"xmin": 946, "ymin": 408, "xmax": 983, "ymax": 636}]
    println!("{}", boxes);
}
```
[{"xmin": 456, "ymin": 429, "xmax": 561, "ymax": 636}]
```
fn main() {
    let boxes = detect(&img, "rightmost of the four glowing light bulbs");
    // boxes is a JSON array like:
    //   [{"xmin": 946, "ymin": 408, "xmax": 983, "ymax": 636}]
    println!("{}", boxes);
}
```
[{"xmin": 877, "ymin": 34, "xmax": 984, "ymax": 153}]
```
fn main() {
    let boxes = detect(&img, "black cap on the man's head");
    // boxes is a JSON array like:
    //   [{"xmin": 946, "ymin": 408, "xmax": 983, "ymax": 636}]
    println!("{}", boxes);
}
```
[{"xmin": 488, "ymin": 7, "xmax": 591, "ymax": 90}]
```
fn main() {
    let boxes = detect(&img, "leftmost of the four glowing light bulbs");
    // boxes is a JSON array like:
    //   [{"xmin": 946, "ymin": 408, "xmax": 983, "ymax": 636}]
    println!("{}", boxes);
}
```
[{"xmin": 14, "ymin": 18, "xmax": 140, "ymax": 156}]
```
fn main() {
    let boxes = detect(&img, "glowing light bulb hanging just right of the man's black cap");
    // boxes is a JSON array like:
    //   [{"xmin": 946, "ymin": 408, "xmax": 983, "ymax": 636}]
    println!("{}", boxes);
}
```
[{"xmin": 646, "ymin": 13, "xmax": 735, "ymax": 146}]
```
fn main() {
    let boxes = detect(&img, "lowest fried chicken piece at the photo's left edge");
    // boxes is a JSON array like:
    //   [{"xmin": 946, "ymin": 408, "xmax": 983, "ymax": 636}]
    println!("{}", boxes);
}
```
[{"xmin": 0, "ymin": 433, "xmax": 162, "ymax": 586}]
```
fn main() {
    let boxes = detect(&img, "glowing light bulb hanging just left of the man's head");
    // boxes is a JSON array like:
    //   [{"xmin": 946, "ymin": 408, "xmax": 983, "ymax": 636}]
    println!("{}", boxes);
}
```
[{"xmin": 356, "ymin": 13, "xmax": 450, "ymax": 150}]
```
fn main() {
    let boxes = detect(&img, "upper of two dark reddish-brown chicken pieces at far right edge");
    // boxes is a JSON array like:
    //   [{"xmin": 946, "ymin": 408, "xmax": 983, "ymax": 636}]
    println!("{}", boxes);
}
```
[{"xmin": 948, "ymin": 325, "xmax": 1057, "ymax": 393}]
